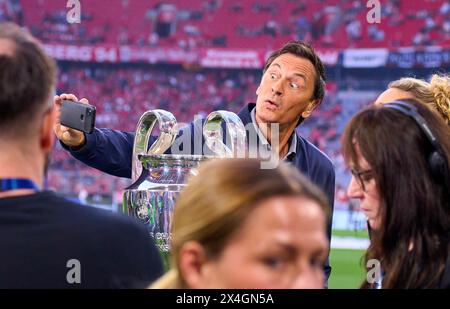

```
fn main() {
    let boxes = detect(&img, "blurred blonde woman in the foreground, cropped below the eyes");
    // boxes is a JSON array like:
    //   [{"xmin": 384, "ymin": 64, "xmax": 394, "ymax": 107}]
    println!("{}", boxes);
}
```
[{"xmin": 152, "ymin": 159, "xmax": 329, "ymax": 289}]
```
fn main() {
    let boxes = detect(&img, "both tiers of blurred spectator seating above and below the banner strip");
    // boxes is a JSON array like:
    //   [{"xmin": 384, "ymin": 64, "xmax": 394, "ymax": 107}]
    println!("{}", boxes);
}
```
[{"xmin": 0, "ymin": 0, "xmax": 450, "ymax": 208}]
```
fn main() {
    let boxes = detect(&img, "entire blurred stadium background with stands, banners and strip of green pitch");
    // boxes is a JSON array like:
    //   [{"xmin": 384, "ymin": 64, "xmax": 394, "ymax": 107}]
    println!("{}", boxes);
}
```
[{"xmin": 0, "ymin": 0, "xmax": 450, "ymax": 288}]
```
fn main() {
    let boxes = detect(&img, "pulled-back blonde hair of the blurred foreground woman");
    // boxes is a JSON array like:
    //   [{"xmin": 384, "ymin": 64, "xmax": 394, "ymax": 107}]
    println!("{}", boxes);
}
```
[{"xmin": 151, "ymin": 159, "xmax": 328, "ymax": 289}]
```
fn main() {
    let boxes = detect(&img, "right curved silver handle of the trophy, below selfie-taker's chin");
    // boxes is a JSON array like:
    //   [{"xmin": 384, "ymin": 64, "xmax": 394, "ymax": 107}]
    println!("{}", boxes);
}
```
[{"xmin": 203, "ymin": 110, "xmax": 247, "ymax": 158}]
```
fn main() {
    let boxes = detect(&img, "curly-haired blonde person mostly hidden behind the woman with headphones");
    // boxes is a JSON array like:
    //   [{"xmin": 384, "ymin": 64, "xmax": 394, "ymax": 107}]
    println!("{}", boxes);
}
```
[{"xmin": 375, "ymin": 74, "xmax": 450, "ymax": 126}]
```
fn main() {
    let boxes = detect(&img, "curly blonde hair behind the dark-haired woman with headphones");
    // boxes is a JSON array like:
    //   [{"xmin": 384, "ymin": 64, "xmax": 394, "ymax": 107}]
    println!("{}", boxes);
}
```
[{"xmin": 388, "ymin": 74, "xmax": 450, "ymax": 126}]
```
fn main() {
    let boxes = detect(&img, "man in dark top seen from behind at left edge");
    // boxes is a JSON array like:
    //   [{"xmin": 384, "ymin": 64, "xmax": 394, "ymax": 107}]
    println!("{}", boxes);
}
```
[{"xmin": 0, "ymin": 24, "xmax": 162, "ymax": 288}]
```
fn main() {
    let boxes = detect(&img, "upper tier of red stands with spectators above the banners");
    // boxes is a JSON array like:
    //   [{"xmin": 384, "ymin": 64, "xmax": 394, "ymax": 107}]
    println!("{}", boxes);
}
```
[{"xmin": 4, "ymin": 0, "xmax": 450, "ymax": 49}]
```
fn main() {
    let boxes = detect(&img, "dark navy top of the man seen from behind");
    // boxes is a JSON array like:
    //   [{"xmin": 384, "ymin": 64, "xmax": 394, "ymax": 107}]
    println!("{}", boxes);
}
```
[{"xmin": 0, "ymin": 191, "xmax": 163, "ymax": 289}]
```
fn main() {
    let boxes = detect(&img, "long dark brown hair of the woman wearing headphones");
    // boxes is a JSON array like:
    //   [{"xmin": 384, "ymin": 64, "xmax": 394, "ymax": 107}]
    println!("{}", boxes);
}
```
[{"xmin": 342, "ymin": 100, "xmax": 450, "ymax": 288}]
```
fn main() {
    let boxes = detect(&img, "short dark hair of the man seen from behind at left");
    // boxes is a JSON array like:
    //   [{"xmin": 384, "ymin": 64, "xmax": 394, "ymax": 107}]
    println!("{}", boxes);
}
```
[{"xmin": 0, "ymin": 23, "xmax": 56, "ymax": 134}]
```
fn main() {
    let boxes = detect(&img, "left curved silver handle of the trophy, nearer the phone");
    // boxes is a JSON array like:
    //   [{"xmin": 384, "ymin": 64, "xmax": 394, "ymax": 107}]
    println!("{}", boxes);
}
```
[{"xmin": 131, "ymin": 109, "xmax": 178, "ymax": 182}]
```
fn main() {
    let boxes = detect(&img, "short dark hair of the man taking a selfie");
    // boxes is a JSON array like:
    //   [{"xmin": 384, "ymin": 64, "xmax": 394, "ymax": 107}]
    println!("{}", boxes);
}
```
[{"xmin": 263, "ymin": 41, "xmax": 326, "ymax": 103}]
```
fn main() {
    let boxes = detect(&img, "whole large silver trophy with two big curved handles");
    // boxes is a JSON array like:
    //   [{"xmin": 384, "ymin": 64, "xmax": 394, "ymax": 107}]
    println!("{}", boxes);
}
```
[{"xmin": 122, "ymin": 109, "xmax": 246, "ymax": 269}]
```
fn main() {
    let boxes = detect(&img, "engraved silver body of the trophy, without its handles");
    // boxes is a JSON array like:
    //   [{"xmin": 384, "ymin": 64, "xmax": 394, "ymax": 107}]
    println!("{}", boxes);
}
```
[{"xmin": 123, "ymin": 155, "xmax": 209, "ymax": 269}]
